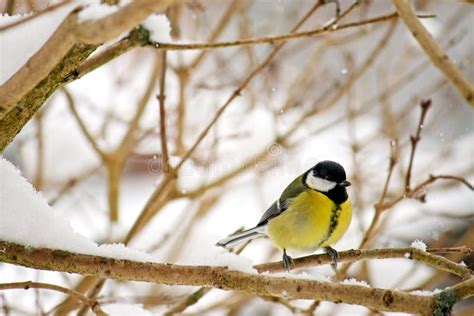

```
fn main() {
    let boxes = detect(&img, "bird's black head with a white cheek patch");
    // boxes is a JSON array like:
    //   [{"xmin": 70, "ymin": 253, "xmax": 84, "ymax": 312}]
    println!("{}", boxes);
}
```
[{"xmin": 303, "ymin": 160, "xmax": 351, "ymax": 204}]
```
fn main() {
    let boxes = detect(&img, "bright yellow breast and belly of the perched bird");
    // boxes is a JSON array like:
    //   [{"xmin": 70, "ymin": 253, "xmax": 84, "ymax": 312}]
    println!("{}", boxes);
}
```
[{"xmin": 267, "ymin": 190, "xmax": 352, "ymax": 251}]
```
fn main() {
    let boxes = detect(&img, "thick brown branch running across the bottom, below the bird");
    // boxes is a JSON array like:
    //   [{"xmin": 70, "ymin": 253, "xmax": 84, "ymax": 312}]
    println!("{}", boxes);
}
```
[{"xmin": 0, "ymin": 241, "xmax": 474, "ymax": 315}]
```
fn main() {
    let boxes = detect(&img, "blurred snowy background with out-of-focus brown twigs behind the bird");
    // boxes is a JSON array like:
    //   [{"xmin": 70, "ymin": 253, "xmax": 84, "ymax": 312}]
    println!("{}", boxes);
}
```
[{"xmin": 0, "ymin": 0, "xmax": 474, "ymax": 315}]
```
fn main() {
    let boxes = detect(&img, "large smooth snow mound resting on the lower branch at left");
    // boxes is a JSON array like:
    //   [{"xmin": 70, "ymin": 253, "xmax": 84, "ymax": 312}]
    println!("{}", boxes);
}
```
[{"xmin": 0, "ymin": 157, "xmax": 155, "ymax": 262}]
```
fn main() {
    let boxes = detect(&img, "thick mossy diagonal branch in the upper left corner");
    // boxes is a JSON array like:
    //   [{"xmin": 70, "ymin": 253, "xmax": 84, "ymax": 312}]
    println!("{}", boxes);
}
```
[{"xmin": 0, "ymin": 0, "xmax": 178, "ymax": 152}]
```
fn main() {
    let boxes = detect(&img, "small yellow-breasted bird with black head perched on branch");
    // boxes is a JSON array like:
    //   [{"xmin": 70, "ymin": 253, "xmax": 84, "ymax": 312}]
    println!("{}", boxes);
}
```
[{"xmin": 216, "ymin": 160, "xmax": 352, "ymax": 271}]
